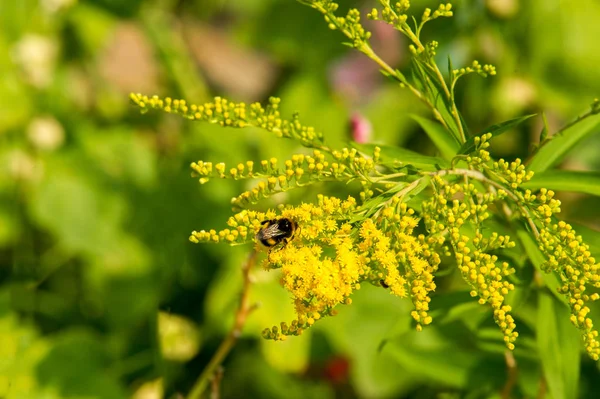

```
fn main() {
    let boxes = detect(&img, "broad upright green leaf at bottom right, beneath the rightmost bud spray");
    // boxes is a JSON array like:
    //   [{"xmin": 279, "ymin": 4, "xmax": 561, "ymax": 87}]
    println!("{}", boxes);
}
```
[{"xmin": 537, "ymin": 291, "xmax": 580, "ymax": 399}]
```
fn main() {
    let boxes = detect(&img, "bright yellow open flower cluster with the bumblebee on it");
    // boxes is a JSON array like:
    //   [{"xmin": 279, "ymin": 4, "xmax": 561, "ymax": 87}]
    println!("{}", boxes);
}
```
[{"xmin": 190, "ymin": 191, "xmax": 440, "ymax": 340}]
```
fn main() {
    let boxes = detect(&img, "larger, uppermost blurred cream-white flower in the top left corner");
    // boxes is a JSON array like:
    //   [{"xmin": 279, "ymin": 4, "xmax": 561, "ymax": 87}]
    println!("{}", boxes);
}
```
[{"xmin": 11, "ymin": 34, "xmax": 58, "ymax": 88}]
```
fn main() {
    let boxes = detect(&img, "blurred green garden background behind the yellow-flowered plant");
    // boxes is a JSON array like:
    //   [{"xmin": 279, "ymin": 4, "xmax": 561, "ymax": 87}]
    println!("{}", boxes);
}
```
[{"xmin": 0, "ymin": 0, "xmax": 600, "ymax": 399}]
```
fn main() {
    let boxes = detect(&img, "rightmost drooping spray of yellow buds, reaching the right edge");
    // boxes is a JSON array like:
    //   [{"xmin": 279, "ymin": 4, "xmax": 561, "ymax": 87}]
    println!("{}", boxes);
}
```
[{"xmin": 523, "ymin": 189, "xmax": 600, "ymax": 360}]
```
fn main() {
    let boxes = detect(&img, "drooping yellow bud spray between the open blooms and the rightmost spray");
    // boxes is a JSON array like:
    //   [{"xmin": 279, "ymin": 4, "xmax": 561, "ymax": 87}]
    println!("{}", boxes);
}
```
[{"xmin": 423, "ymin": 176, "xmax": 518, "ymax": 350}]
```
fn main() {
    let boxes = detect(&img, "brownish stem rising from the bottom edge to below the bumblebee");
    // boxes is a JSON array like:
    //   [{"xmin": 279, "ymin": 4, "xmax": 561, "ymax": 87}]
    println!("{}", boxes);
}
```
[{"xmin": 187, "ymin": 251, "xmax": 257, "ymax": 399}]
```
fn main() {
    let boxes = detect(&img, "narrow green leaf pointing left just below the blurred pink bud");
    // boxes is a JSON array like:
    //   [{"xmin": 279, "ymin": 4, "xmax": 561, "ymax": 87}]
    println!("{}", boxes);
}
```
[{"xmin": 350, "ymin": 143, "xmax": 450, "ymax": 171}]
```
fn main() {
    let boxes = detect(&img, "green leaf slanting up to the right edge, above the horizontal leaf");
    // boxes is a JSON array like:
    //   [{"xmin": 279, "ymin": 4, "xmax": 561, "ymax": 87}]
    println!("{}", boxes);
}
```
[{"xmin": 529, "ymin": 115, "xmax": 600, "ymax": 172}]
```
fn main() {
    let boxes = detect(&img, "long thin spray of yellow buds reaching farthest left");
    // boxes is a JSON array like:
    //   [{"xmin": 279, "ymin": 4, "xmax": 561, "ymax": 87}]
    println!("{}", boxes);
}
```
[{"xmin": 130, "ymin": 93, "xmax": 323, "ymax": 147}]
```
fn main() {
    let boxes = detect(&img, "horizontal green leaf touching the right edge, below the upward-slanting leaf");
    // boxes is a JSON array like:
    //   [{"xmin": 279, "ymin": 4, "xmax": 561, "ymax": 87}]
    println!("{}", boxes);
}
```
[{"xmin": 521, "ymin": 170, "xmax": 600, "ymax": 196}]
